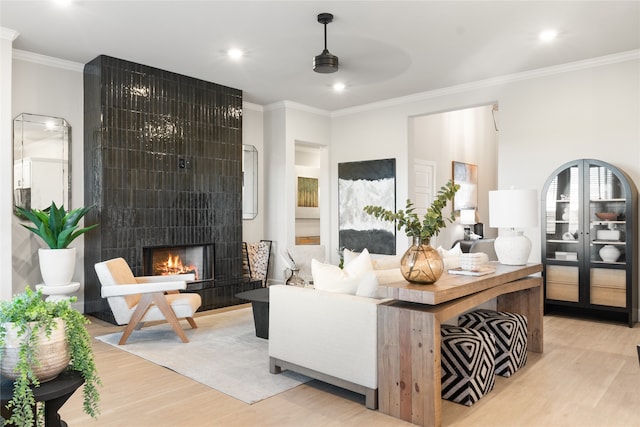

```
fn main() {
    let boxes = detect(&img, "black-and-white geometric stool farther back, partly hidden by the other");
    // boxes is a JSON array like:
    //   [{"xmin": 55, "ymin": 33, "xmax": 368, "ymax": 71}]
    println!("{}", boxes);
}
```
[{"xmin": 458, "ymin": 310, "xmax": 527, "ymax": 377}]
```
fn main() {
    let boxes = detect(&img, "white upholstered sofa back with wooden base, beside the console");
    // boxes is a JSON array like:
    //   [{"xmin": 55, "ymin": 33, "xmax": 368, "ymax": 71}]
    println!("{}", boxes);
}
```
[{"xmin": 269, "ymin": 285, "xmax": 386, "ymax": 409}]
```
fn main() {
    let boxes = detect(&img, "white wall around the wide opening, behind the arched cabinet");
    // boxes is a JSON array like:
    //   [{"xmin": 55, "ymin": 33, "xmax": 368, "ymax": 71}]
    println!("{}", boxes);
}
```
[{"xmin": 331, "ymin": 51, "xmax": 640, "ymax": 314}]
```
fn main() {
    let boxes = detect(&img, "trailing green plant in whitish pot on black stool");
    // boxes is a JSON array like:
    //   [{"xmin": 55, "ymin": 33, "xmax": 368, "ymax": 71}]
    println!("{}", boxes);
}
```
[{"xmin": 0, "ymin": 287, "xmax": 101, "ymax": 426}]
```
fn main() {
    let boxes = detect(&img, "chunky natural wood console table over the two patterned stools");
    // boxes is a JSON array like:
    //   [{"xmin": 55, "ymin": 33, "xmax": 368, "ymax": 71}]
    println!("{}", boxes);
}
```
[{"xmin": 378, "ymin": 263, "xmax": 543, "ymax": 427}]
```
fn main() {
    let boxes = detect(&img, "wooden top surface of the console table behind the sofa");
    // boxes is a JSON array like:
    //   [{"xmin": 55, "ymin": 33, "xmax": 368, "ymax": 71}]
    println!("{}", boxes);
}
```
[{"xmin": 379, "ymin": 261, "xmax": 542, "ymax": 305}]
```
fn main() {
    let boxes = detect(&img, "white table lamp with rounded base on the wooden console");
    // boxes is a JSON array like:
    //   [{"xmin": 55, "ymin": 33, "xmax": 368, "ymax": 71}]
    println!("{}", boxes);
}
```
[{"xmin": 489, "ymin": 190, "xmax": 538, "ymax": 265}]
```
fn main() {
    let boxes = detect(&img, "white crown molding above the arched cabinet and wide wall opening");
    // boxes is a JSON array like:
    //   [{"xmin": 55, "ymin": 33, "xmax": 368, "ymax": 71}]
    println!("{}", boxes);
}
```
[{"xmin": 331, "ymin": 49, "xmax": 640, "ymax": 117}]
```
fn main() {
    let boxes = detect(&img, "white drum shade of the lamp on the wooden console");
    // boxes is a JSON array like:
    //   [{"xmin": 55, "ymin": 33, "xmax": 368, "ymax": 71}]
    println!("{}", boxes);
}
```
[{"xmin": 489, "ymin": 190, "xmax": 538, "ymax": 228}]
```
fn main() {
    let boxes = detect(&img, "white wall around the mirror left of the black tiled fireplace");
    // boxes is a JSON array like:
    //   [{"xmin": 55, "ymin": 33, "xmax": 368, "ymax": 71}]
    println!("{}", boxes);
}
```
[{"xmin": 10, "ymin": 51, "xmax": 84, "ymax": 307}]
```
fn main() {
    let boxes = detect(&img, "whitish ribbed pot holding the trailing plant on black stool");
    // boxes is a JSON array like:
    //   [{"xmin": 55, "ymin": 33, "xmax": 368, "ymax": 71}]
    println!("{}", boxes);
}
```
[{"xmin": 0, "ymin": 319, "xmax": 70, "ymax": 382}]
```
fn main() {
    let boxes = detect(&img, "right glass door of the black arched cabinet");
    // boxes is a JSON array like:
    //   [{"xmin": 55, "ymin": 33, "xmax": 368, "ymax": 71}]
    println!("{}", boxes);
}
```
[{"xmin": 588, "ymin": 165, "xmax": 629, "ymax": 307}]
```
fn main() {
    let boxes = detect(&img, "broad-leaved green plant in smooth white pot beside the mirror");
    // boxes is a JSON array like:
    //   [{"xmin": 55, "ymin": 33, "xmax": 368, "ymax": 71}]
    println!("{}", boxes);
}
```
[{"xmin": 16, "ymin": 201, "xmax": 98, "ymax": 286}]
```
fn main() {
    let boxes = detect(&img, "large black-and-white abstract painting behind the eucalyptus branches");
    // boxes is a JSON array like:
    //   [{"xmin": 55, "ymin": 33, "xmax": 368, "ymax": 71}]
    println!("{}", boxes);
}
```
[{"xmin": 338, "ymin": 159, "xmax": 396, "ymax": 255}]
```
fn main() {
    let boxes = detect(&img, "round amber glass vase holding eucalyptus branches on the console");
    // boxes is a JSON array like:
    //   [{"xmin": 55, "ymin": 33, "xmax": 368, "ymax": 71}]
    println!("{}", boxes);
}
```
[{"xmin": 400, "ymin": 237, "xmax": 444, "ymax": 283}]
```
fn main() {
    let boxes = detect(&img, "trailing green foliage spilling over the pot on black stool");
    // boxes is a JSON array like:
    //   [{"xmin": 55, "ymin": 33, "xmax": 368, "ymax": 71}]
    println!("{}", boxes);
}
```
[{"xmin": 0, "ymin": 287, "xmax": 102, "ymax": 426}]
